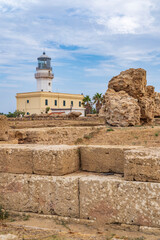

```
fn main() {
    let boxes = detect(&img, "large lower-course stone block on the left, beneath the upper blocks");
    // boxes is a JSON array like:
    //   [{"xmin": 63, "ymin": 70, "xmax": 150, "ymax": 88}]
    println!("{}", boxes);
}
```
[{"xmin": 0, "ymin": 173, "xmax": 79, "ymax": 217}]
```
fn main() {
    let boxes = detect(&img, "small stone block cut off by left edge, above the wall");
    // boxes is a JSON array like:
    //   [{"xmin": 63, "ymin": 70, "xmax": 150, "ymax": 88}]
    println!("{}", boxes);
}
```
[{"xmin": 0, "ymin": 115, "xmax": 9, "ymax": 141}]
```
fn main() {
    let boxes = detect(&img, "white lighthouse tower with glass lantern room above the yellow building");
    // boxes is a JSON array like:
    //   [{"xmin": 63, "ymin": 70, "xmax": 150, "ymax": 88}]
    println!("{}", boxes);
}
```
[{"xmin": 35, "ymin": 52, "xmax": 54, "ymax": 92}]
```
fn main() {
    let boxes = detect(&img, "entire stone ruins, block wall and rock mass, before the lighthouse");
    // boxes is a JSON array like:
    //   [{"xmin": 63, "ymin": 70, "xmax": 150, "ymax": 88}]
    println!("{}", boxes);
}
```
[{"xmin": 0, "ymin": 69, "xmax": 160, "ymax": 239}]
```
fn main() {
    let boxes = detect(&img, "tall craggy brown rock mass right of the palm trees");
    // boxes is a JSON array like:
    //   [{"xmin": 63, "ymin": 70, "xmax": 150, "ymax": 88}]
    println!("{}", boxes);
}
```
[{"xmin": 100, "ymin": 68, "xmax": 160, "ymax": 127}]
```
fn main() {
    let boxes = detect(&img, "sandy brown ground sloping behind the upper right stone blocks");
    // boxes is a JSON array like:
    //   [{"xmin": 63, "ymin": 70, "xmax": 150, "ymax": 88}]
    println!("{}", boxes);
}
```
[{"xmin": 77, "ymin": 126, "xmax": 160, "ymax": 147}]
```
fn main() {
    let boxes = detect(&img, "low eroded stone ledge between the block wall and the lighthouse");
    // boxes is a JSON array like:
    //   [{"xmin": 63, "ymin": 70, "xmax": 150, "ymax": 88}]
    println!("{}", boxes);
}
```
[{"xmin": 10, "ymin": 125, "xmax": 104, "ymax": 145}]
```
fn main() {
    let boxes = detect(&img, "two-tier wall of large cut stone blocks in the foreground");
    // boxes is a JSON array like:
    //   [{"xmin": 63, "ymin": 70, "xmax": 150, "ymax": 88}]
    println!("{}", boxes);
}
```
[{"xmin": 0, "ymin": 145, "xmax": 160, "ymax": 228}]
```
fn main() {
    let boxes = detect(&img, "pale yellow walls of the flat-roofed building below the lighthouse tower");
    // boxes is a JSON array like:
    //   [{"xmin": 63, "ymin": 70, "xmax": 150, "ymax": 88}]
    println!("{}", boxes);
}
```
[{"xmin": 16, "ymin": 92, "xmax": 84, "ymax": 114}]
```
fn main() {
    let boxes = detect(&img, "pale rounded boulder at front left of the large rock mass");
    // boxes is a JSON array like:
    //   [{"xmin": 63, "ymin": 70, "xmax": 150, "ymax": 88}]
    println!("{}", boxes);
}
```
[{"xmin": 102, "ymin": 89, "xmax": 140, "ymax": 127}]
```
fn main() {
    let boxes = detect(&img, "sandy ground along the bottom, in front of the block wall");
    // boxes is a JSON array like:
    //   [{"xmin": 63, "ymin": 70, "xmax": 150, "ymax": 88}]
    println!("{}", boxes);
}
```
[{"xmin": 0, "ymin": 218, "xmax": 160, "ymax": 240}]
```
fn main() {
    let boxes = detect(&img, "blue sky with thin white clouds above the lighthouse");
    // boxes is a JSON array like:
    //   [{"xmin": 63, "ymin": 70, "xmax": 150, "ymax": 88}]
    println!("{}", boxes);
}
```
[{"xmin": 0, "ymin": 0, "xmax": 160, "ymax": 113}]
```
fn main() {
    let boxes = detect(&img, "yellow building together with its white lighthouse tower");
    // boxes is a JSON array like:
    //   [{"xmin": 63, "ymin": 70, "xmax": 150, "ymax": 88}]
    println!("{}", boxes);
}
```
[{"xmin": 16, "ymin": 52, "xmax": 85, "ymax": 116}]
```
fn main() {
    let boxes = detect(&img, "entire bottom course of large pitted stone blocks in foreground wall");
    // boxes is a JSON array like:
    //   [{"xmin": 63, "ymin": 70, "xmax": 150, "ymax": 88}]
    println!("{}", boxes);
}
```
[{"xmin": 0, "ymin": 173, "xmax": 160, "ymax": 227}]
